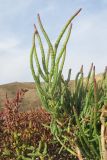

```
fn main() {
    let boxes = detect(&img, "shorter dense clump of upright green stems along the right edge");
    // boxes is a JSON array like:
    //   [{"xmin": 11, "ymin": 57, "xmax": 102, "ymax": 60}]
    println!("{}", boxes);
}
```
[{"xmin": 72, "ymin": 64, "xmax": 107, "ymax": 160}]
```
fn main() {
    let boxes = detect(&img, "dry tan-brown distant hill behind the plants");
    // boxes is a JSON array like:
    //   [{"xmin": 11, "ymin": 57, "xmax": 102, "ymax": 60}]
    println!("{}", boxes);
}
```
[{"xmin": 0, "ymin": 74, "xmax": 102, "ymax": 111}]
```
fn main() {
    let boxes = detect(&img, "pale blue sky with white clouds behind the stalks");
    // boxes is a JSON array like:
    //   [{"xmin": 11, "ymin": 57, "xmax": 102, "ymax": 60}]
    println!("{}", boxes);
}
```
[{"xmin": 0, "ymin": 0, "xmax": 107, "ymax": 84}]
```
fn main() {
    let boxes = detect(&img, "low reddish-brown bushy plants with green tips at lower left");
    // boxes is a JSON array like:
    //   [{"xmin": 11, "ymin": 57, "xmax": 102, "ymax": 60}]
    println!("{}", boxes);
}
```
[{"xmin": 0, "ymin": 90, "xmax": 71, "ymax": 160}]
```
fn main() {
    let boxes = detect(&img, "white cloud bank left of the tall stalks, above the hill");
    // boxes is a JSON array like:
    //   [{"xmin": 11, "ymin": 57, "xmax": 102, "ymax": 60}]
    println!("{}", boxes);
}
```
[{"xmin": 0, "ymin": 34, "xmax": 31, "ymax": 84}]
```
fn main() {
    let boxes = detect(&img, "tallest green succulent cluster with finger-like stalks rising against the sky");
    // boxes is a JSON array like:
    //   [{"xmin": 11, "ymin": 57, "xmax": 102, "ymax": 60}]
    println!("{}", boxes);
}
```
[{"xmin": 30, "ymin": 9, "xmax": 81, "ymax": 127}]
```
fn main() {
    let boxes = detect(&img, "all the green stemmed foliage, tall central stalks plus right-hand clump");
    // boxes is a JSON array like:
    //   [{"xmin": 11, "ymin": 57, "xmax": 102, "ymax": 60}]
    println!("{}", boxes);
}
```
[{"xmin": 30, "ymin": 9, "xmax": 107, "ymax": 160}]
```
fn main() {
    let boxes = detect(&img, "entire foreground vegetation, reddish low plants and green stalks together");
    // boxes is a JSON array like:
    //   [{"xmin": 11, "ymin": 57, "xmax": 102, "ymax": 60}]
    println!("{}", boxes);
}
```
[{"xmin": 0, "ymin": 9, "xmax": 107, "ymax": 160}]
